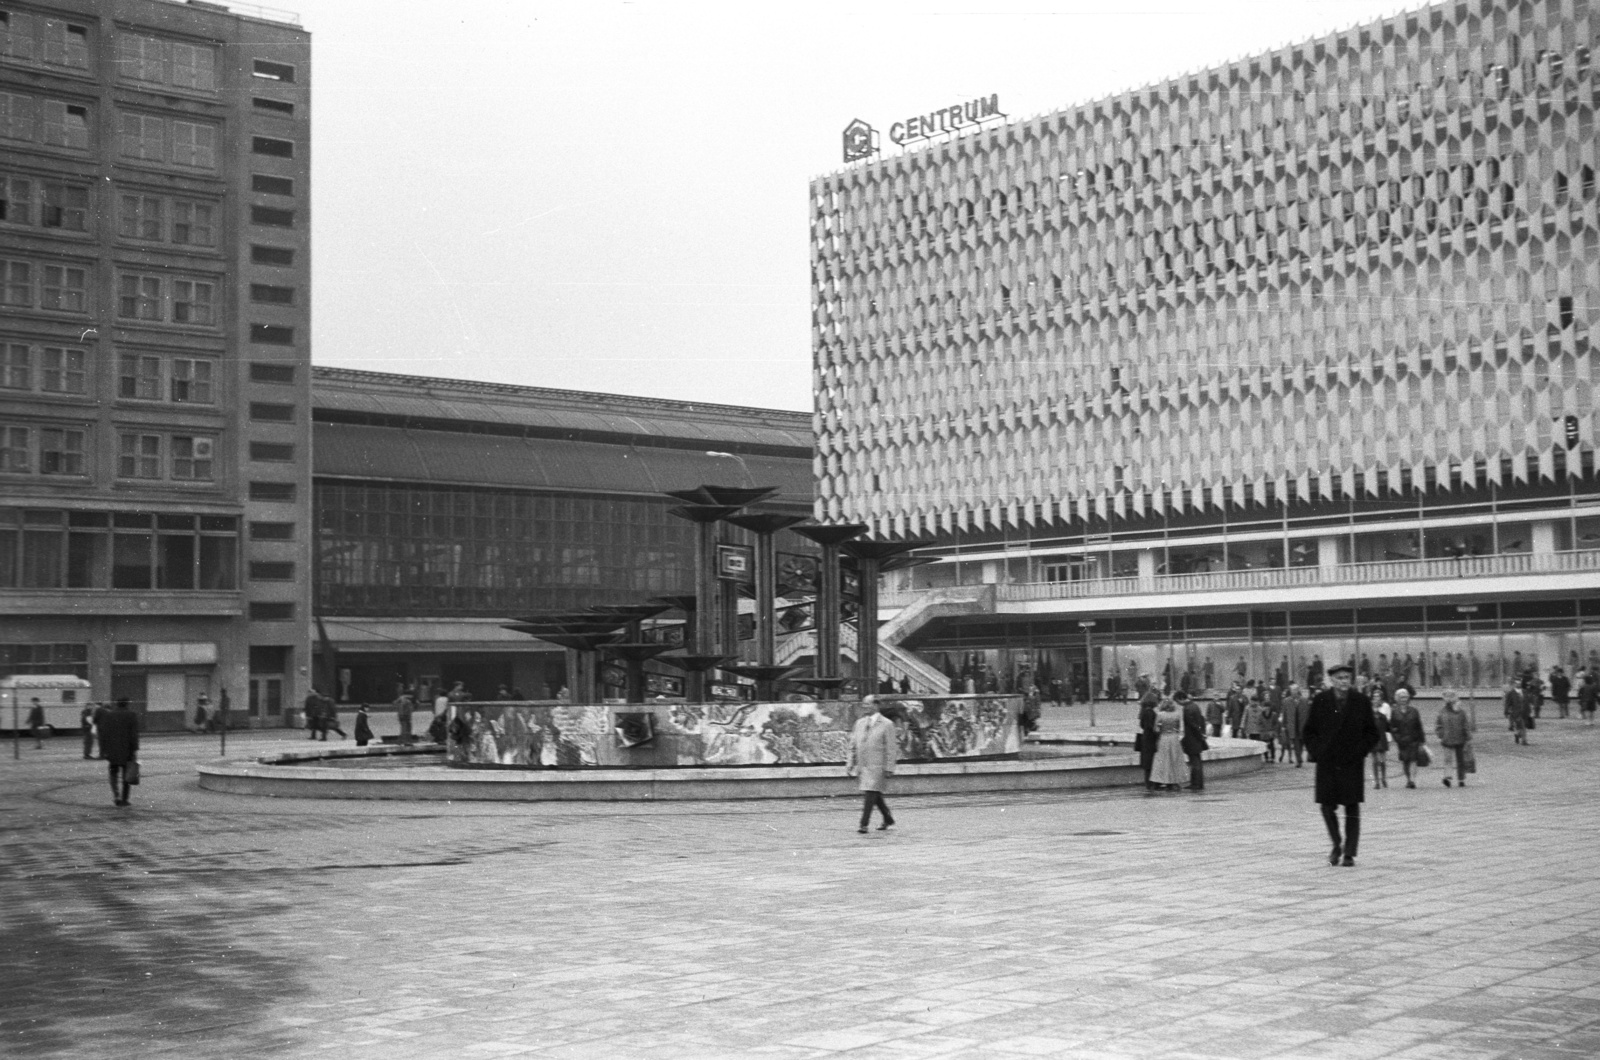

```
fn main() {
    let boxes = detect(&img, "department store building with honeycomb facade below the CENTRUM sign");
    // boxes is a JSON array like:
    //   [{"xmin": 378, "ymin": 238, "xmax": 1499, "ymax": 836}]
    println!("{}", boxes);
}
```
[{"xmin": 811, "ymin": 0, "xmax": 1600, "ymax": 704}]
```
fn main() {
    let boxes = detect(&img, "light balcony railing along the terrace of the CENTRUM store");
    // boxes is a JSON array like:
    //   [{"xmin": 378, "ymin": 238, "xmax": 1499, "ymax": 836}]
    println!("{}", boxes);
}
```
[{"xmin": 878, "ymin": 551, "xmax": 1600, "ymax": 607}]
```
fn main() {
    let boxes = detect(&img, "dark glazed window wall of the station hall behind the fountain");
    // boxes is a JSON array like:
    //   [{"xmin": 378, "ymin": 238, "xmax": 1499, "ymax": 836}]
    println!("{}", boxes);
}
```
[{"xmin": 315, "ymin": 482, "xmax": 694, "ymax": 616}]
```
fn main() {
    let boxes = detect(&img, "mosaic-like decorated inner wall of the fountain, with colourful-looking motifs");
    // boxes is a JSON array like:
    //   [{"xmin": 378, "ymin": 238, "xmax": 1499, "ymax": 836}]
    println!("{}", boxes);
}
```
[{"xmin": 445, "ymin": 695, "xmax": 1022, "ymax": 769}]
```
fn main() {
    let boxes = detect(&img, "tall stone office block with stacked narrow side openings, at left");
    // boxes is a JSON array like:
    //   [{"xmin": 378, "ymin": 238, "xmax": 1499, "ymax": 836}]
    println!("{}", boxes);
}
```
[{"xmin": 0, "ymin": 0, "xmax": 310, "ymax": 727}]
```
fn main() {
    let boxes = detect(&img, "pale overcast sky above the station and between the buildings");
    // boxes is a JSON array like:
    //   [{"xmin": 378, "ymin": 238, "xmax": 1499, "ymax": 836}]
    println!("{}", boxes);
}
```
[{"xmin": 294, "ymin": 0, "xmax": 1419, "ymax": 410}]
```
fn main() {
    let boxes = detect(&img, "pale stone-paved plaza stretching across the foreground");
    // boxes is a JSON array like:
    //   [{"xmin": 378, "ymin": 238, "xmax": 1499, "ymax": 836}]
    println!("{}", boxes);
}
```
[{"xmin": 0, "ymin": 711, "xmax": 1600, "ymax": 1060}]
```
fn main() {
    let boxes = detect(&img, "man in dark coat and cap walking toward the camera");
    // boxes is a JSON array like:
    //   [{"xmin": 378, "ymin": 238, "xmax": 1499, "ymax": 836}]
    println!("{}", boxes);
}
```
[{"xmin": 1301, "ymin": 663, "xmax": 1378, "ymax": 866}]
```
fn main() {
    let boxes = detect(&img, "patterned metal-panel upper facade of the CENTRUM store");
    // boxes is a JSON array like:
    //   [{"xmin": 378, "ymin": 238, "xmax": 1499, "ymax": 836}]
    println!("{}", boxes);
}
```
[{"xmin": 811, "ymin": 0, "xmax": 1600, "ymax": 535}]
